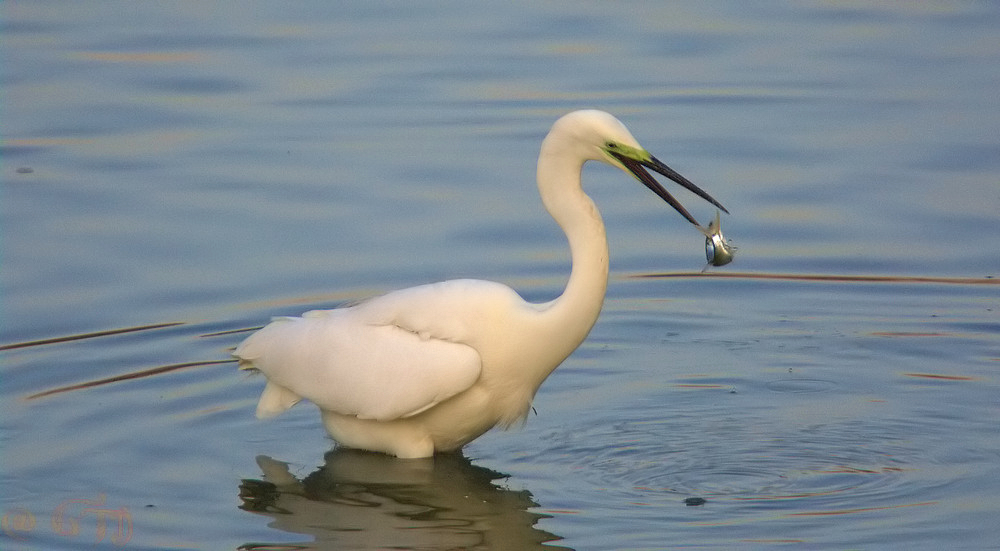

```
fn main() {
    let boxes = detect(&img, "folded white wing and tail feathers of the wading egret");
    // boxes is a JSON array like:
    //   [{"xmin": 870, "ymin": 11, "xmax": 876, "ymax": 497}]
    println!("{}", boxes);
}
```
[{"xmin": 234, "ymin": 308, "xmax": 482, "ymax": 421}]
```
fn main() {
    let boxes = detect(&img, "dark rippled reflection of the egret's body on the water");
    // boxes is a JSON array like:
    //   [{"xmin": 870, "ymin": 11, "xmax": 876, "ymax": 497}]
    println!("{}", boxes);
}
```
[{"xmin": 240, "ymin": 449, "xmax": 566, "ymax": 549}]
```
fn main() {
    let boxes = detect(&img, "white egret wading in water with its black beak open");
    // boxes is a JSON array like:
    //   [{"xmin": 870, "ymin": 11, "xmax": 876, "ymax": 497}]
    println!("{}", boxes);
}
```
[{"xmin": 233, "ymin": 111, "xmax": 728, "ymax": 458}]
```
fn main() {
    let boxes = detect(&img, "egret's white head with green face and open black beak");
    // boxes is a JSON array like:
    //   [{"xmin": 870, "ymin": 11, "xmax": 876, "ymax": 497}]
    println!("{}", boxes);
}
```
[{"xmin": 553, "ymin": 110, "xmax": 729, "ymax": 227}]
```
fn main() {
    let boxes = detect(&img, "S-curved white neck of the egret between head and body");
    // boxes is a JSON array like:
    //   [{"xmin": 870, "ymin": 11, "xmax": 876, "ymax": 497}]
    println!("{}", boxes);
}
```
[{"xmin": 538, "ymin": 139, "xmax": 608, "ymax": 356}]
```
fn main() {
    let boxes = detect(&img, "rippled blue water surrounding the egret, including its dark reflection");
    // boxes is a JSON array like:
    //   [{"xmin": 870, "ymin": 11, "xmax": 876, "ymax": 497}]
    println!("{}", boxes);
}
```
[{"xmin": 0, "ymin": 1, "xmax": 1000, "ymax": 549}]
